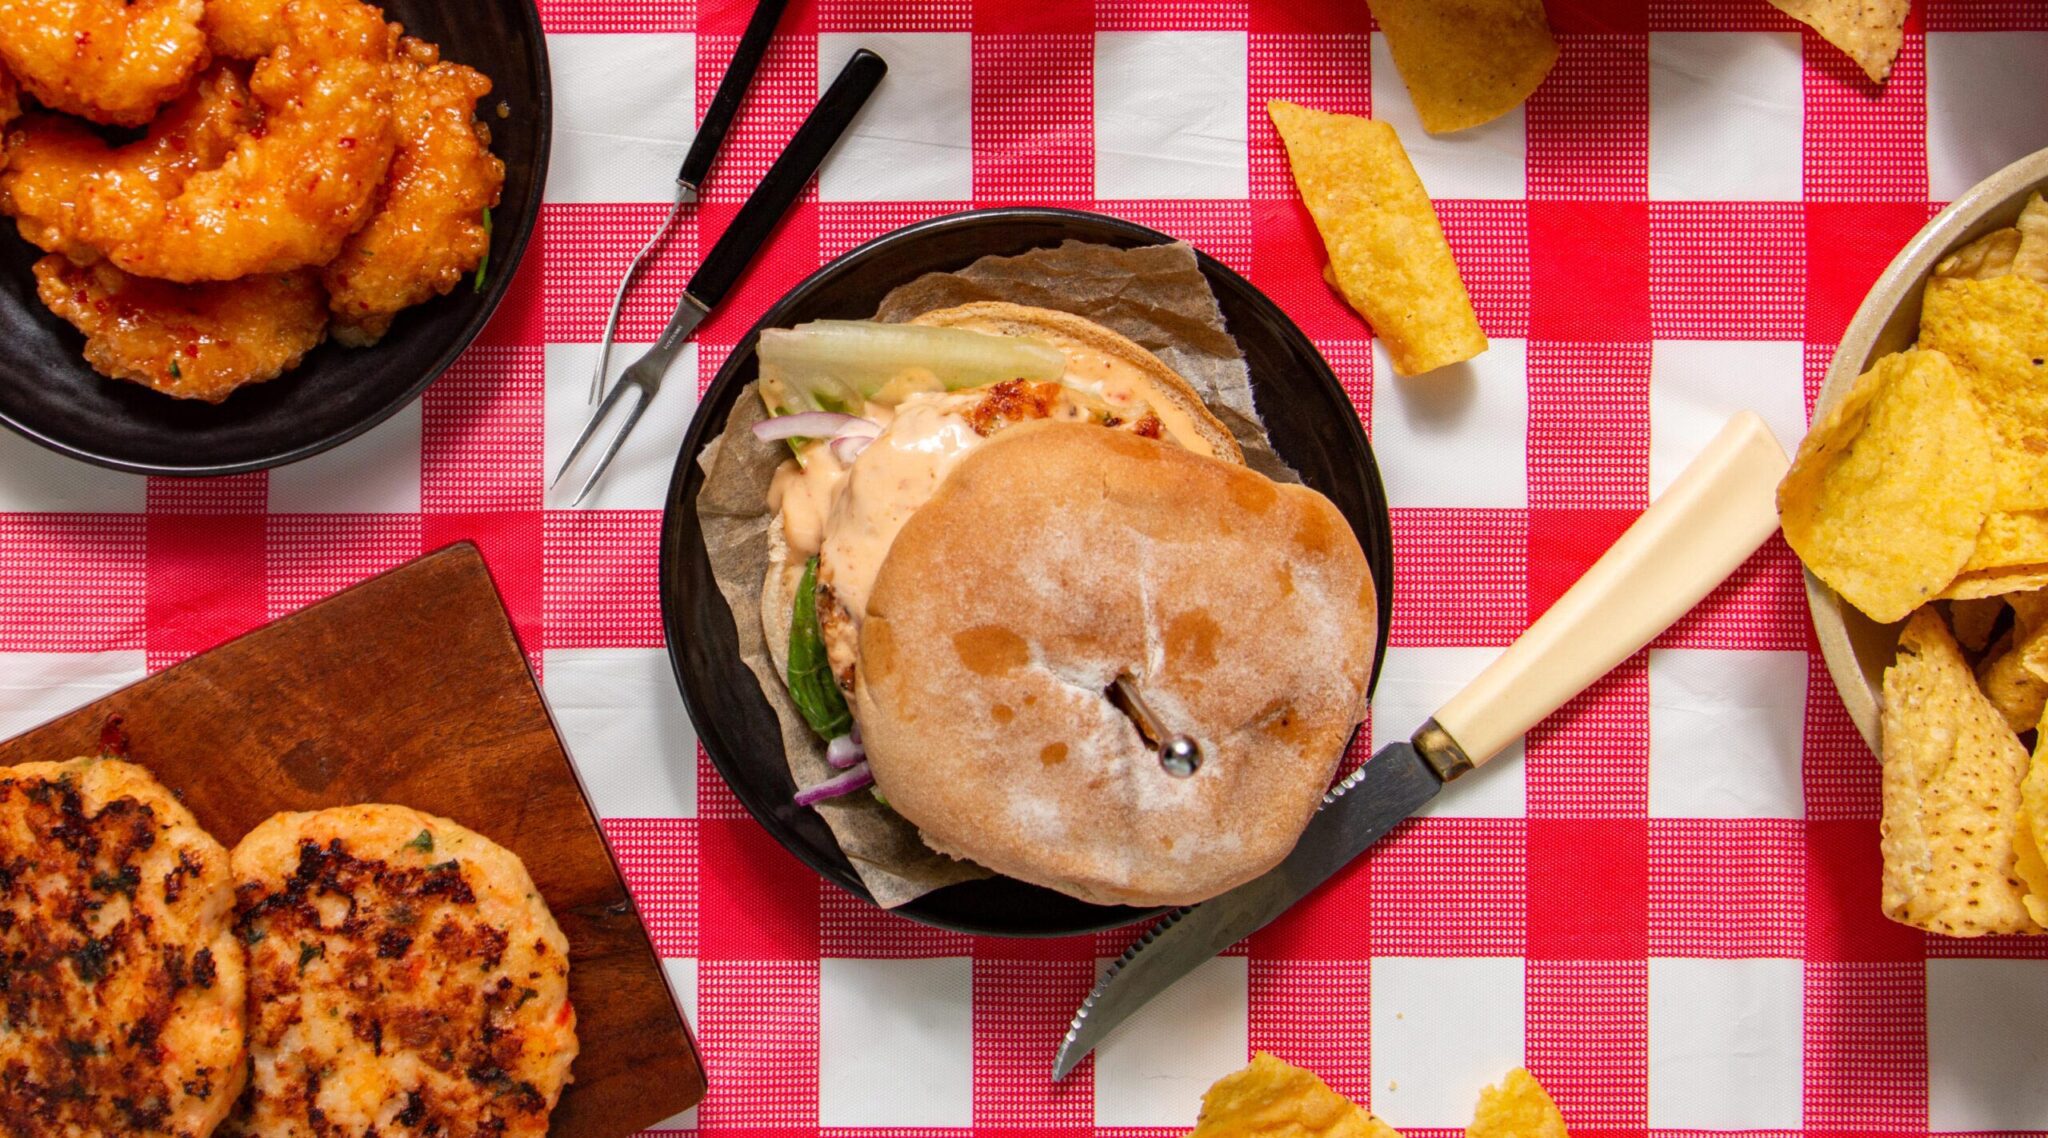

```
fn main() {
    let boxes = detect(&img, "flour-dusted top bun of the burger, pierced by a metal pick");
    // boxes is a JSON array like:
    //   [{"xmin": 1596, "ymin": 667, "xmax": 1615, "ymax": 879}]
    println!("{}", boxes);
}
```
[{"xmin": 856, "ymin": 422, "xmax": 1376, "ymax": 905}]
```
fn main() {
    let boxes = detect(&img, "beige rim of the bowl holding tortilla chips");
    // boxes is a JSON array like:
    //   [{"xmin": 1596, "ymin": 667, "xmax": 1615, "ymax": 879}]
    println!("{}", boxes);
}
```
[{"xmin": 1800, "ymin": 149, "xmax": 2048, "ymax": 753}]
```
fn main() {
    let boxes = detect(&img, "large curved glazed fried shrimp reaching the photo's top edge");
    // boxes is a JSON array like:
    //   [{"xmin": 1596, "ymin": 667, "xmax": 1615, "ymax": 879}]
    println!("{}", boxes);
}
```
[{"xmin": 92, "ymin": 0, "xmax": 395, "ymax": 282}]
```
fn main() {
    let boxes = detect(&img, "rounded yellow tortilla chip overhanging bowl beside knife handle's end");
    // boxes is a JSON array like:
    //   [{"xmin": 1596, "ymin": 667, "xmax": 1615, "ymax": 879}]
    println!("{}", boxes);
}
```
[{"xmin": 1778, "ymin": 352, "xmax": 1993, "ymax": 624}]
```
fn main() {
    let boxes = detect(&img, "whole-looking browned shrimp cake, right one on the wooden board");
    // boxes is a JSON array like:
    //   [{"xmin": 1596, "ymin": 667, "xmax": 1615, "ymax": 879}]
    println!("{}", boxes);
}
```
[{"xmin": 231, "ymin": 804, "xmax": 575, "ymax": 1138}]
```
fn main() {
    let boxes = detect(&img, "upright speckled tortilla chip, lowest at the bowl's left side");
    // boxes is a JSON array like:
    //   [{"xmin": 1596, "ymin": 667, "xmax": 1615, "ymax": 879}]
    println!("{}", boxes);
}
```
[{"xmin": 1880, "ymin": 608, "xmax": 2042, "ymax": 937}]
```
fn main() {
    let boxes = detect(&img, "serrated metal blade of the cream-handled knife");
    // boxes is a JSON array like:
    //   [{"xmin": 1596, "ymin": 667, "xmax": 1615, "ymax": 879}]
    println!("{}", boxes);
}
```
[{"xmin": 1053, "ymin": 743, "xmax": 1444, "ymax": 1081}]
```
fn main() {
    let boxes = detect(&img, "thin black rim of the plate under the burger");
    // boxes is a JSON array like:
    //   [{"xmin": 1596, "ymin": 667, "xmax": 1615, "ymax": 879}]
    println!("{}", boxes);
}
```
[{"xmin": 659, "ymin": 205, "xmax": 1395, "ymax": 939}]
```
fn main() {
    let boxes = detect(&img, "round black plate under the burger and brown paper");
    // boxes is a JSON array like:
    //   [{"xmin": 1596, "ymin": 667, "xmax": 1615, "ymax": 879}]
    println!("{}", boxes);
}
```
[{"xmin": 662, "ymin": 209, "xmax": 1393, "ymax": 937}]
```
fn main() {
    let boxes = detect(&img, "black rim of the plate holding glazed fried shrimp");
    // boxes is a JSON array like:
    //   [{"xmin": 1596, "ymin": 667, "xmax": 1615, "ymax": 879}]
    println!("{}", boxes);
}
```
[{"xmin": 0, "ymin": 0, "xmax": 555, "ymax": 479}]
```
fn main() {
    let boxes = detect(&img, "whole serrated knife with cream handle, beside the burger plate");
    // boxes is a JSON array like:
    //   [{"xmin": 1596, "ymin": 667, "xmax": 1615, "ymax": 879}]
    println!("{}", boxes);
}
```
[{"xmin": 1053, "ymin": 411, "xmax": 1790, "ymax": 1081}]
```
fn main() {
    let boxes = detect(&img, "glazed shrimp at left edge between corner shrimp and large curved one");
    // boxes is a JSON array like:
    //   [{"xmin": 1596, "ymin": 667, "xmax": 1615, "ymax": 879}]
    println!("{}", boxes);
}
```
[{"xmin": 0, "ymin": 65, "xmax": 262, "ymax": 264}]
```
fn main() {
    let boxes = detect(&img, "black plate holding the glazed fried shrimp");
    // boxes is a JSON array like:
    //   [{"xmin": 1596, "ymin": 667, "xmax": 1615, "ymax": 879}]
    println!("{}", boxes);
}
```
[{"xmin": 0, "ymin": 0, "xmax": 553, "ymax": 475}]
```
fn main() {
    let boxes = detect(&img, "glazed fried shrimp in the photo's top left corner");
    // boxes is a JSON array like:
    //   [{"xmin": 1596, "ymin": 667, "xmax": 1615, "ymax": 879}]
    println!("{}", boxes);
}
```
[{"xmin": 0, "ymin": 0, "xmax": 211, "ymax": 127}]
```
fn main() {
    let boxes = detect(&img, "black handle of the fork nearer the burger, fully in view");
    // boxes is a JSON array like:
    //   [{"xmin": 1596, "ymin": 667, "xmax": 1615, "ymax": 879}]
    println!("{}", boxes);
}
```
[{"xmin": 684, "ymin": 47, "xmax": 889, "ymax": 309}]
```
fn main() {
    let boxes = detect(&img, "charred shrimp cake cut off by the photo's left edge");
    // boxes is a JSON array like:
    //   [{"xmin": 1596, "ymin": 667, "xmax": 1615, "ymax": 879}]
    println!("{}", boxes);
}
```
[{"xmin": 0, "ymin": 759, "xmax": 246, "ymax": 1138}]
